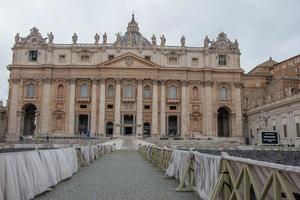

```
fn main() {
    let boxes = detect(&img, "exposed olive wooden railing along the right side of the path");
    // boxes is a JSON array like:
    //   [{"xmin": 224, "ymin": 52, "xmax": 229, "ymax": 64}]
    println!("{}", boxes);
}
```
[{"xmin": 139, "ymin": 145, "xmax": 300, "ymax": 200}]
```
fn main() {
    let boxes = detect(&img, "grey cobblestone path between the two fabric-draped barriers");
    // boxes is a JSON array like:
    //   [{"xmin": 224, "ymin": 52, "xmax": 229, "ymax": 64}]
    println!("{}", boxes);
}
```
[{"xmin": 35, "ymin": 151, "xmax": 200, "ymax": 200}]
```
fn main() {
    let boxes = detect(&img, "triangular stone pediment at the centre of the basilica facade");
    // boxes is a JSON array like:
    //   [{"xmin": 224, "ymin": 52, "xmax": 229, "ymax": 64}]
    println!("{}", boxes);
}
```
[{"xmin": 99, "ymin": 53, "xmax": 159, "ymax": 69}]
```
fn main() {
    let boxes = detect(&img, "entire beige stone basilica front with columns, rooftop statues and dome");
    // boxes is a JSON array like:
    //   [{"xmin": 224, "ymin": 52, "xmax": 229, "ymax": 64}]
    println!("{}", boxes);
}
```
[{"xmin": 7, "ymin": 16, "xmax": 243, "ymax": 140}]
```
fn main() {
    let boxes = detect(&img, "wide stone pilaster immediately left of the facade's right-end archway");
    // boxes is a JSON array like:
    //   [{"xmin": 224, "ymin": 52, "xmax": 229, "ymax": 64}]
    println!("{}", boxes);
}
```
[{"xmin": 203, "ymin": 81, "xmax": 213, "ymax": 135}]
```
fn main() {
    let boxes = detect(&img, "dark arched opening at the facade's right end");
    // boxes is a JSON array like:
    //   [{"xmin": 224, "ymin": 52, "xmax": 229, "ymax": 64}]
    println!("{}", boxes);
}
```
[{"xmin": 218, "ymin": 107, "xmax": 230, "ymax": 137}]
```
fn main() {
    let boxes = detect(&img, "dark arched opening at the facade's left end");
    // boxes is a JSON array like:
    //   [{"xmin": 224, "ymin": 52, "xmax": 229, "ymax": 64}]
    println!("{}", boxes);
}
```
[{"xmin": 23, "ymin": 104, "xmax": 36, "ymax": 136}]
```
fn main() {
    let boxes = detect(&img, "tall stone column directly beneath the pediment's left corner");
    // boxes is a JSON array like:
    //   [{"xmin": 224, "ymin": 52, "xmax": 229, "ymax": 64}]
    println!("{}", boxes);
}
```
[{"xmin": 99, "ymin": 79, "xmax": 105, "ymax": 135}]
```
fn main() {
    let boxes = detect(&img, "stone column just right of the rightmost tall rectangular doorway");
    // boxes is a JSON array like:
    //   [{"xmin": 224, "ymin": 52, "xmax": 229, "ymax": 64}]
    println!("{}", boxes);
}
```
[{"xmin": 181, "ymin": 81, "xmax": 188, "ymax": 136}]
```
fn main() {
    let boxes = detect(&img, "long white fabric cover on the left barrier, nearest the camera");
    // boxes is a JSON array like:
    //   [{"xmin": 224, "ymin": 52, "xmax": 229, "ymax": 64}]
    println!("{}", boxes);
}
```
[{"xmin": 0, "ymin": 147, "xmax": 78, "ymax": 200}]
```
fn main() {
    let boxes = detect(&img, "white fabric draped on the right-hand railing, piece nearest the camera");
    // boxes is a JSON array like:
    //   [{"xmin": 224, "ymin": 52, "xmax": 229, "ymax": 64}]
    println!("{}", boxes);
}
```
[{"xmin": 193, "ymin": 152, "xmax": 221, "ymax": 200}]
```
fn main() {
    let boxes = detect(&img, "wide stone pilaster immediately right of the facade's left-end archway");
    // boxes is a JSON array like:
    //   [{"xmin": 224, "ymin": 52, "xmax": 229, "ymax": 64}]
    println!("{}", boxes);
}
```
[{"xmin": 41, "ymin": 78, "xmax": 51, "ymax": 135}]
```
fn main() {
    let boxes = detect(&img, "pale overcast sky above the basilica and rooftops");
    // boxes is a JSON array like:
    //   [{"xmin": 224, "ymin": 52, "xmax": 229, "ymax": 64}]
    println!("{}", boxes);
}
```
[{"xmin": 0, "ymin": 0, "xmax": 300, "ymax": 101}]
